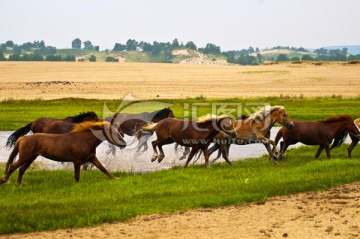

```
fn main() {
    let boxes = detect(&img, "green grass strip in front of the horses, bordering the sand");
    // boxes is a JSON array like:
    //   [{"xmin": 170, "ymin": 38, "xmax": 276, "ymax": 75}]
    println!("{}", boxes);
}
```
[{"xmin": 0, "ymin": 145, "xmax": 360, "ymax": 234}]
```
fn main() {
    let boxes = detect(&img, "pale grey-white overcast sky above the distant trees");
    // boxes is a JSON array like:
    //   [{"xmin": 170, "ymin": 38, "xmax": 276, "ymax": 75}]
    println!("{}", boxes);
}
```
[{"xmin": 0, "ymin": 0, "xmax": 360, "ymax": 51}]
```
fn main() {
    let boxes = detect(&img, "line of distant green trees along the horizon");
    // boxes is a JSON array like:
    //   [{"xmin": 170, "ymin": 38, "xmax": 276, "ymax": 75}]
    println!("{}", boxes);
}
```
[{"xmin": 0, "ymin": 38, "xmax": 360, "ymax": 65}]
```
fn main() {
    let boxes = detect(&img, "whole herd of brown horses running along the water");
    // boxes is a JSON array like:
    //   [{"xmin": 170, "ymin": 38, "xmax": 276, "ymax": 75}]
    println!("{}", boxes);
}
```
[{"xmin": 0, "ymin": 106, "xmax": 360, "ymax": 185}]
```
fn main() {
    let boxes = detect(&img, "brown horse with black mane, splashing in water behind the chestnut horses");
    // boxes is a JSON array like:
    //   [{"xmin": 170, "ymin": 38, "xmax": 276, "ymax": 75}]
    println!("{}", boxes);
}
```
[{"xmin": 105, "ymin": 108, "xmax": 175, "ymax": 152}]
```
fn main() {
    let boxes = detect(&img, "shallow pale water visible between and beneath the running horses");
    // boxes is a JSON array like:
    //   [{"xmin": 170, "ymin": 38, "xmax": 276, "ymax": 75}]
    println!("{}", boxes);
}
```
[{"xmin": 0, "ymin": 127, "xmax": 350, "ymax": 173}]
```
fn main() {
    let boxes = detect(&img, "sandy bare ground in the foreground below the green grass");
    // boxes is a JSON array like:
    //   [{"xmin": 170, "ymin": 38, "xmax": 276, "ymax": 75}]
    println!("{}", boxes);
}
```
[{"xmin": 0, "ymin": 182, "xmax": 360, "ymax": 239}]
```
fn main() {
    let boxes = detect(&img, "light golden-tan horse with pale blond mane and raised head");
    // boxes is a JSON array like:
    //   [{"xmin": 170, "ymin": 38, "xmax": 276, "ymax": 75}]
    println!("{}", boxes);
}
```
[{"xmin": 209, "ymin": 106, "xmax": 293, "ymax": 165}]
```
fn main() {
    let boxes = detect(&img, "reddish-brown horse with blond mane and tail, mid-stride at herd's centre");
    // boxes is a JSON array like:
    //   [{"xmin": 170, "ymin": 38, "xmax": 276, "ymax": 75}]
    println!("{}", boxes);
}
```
[{"xmin": 137, "ymin": 115, "xmax": 236, "ymax": 168}]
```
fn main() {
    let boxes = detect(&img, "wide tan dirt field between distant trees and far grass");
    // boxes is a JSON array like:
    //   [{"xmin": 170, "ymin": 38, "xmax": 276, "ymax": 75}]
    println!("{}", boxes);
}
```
[{"xmin": 0, "ymin": 62, "xmax": 360, "ymax": 100}]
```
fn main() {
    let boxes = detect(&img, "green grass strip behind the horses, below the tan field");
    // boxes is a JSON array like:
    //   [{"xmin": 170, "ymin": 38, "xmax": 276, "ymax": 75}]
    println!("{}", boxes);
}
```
[{"xmin": 0, "ymin": 96, "xmax": 360, "ymax": 130}]
